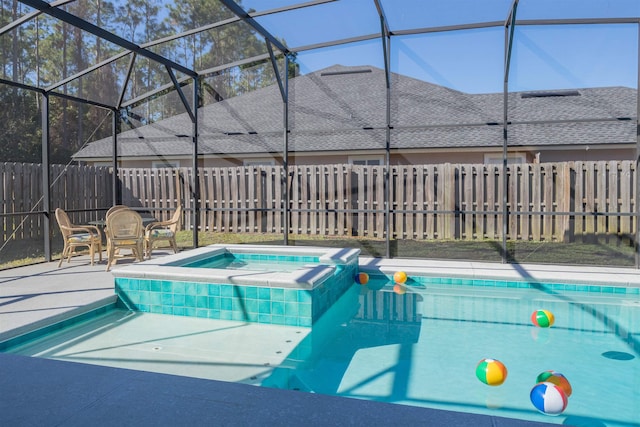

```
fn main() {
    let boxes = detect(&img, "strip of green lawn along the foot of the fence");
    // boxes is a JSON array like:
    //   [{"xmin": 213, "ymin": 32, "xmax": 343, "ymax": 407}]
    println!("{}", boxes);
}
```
[{"xmin": 0, "ymin": 231, "xmax": 635, "ymax": 270}]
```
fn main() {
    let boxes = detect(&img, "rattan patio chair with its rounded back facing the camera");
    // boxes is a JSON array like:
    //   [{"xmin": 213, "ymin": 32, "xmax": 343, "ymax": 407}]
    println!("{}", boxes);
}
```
[{"xmin": 105, "ymin": 209, "xmax": 144, "ymax": 271}]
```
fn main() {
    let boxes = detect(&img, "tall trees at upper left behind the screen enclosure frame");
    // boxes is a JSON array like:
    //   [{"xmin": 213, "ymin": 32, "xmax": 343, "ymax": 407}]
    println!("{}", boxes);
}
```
[{"xmin": 0, "ymin": 0, "xmax": 290, "ymax": 163}]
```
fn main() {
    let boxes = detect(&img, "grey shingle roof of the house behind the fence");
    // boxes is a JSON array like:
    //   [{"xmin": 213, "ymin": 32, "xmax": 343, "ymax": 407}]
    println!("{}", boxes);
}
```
[{"xmin": 74, "ymin": 65, "xmax": 637, "ymax": 160}]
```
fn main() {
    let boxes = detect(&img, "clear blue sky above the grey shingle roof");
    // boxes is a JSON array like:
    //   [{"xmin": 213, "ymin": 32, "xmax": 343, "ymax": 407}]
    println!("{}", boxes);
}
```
[{"xmin": 242, "ymin": 0, "xmax": 640, "ymax": 93}]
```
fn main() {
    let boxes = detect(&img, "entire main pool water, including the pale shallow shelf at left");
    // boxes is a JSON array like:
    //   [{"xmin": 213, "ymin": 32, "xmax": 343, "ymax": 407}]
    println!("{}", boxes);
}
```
[{"xmin": 10, "ymin": 277, "xmax": 640, "ymax": 427}]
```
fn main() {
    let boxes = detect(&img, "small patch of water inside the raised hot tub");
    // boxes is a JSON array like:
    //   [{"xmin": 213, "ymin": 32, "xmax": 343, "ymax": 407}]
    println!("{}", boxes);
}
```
[{"xmin": 183, "ymin": 252, "xmax": 319, "ymax": 272}]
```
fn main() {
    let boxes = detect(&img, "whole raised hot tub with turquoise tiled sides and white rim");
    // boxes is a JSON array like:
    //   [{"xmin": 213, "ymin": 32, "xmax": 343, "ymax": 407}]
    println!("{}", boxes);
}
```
[{"xmin": 112, "ymin": 245, "xmax": 360, "ymax": 326}]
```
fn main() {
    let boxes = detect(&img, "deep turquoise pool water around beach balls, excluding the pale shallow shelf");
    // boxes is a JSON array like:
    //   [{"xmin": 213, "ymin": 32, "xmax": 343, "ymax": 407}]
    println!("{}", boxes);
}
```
[{"xmin": 273, "ymin": 280, "xmax": 640, "ymax": 426}]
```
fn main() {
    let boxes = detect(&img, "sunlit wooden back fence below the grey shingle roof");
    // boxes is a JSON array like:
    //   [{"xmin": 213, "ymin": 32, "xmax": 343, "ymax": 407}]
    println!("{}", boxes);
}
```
[{"xmin": 119, "ymin": 161, "xmax": 636, "ymax": 241}]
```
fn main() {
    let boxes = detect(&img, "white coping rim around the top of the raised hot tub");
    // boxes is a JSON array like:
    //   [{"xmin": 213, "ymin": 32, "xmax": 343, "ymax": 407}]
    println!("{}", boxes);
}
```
[{"xmin": 112, "ymin": 244, "xmax": 360, "ymax": 289}]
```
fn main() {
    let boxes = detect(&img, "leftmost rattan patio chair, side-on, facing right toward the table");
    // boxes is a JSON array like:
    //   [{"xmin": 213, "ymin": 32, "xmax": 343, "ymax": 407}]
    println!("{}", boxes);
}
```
[{"xmin": 55, "ymin": 208, "xmax": 102, "ymax": 267}]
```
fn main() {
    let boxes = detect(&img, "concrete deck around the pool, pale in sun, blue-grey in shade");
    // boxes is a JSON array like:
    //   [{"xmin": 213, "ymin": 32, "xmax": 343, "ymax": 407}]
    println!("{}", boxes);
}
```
[{"xmin": 0, "ymin": 253, "xmax": 640, "ymax": 426}]
